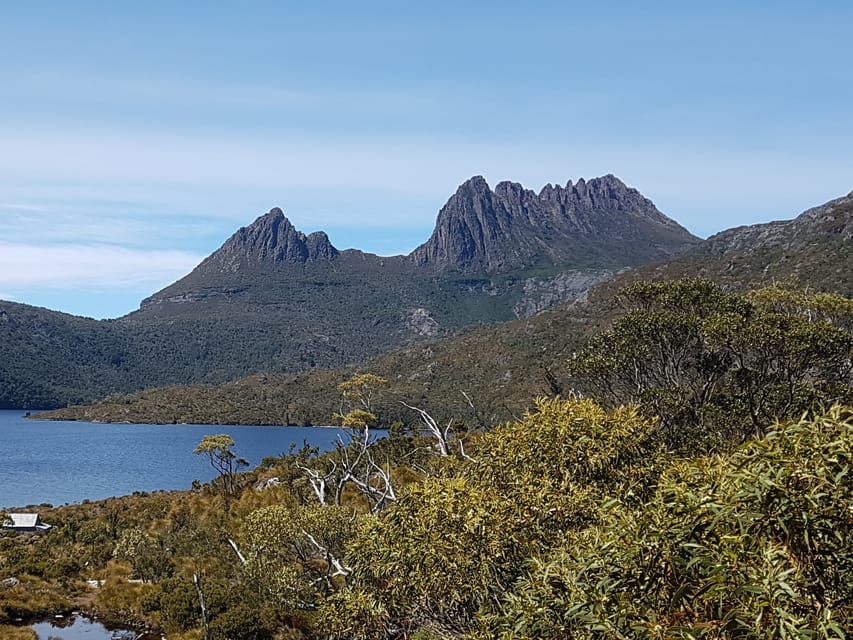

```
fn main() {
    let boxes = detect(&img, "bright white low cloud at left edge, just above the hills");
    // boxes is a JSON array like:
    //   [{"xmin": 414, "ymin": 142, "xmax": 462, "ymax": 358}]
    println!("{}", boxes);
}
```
[{"xmin": 0, "ymin": 243, "xmax": 203, "ymax": 291}]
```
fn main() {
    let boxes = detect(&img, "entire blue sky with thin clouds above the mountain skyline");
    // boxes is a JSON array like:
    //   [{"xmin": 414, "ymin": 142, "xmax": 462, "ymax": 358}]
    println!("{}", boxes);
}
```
[{"xmin": 0, "ymin": 1, "xmax": 853, "ymax": 317}]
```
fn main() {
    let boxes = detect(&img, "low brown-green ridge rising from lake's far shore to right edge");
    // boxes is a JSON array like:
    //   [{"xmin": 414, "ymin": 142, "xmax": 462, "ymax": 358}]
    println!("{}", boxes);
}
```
[{"xmin": 38, "ymin": 185, "xmax": 853, "ymax": 424}]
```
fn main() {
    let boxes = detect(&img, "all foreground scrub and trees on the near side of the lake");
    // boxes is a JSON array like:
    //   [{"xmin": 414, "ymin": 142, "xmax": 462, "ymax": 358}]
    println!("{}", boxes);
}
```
[{"xmin": 6, "ymin": 280, "xmax": 853, "ymax": 640}]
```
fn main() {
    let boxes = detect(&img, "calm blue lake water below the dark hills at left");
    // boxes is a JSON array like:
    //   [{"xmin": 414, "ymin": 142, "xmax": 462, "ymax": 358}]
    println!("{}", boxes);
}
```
[{"xmin": 0, "ymin": 411, "xmax": 352, "ymax": 509}]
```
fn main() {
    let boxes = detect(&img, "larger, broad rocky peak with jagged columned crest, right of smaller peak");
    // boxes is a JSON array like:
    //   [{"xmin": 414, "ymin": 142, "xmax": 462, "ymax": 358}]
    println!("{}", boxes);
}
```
[{"xmin": 410, "ymin": 175, "xmax": 699, "ymax": 273}]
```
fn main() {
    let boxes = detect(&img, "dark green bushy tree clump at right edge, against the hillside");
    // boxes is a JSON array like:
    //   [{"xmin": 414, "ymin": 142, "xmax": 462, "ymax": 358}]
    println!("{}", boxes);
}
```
[{"xmin": 570, "ymin": 278, "xmax": 853, "ymax": 447}]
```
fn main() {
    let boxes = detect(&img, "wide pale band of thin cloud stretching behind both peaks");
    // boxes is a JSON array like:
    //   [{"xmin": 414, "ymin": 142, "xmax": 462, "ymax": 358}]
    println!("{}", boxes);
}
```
[{"xmin": 0, "ymin": 127, "xmax": 853, "ymax": 242}]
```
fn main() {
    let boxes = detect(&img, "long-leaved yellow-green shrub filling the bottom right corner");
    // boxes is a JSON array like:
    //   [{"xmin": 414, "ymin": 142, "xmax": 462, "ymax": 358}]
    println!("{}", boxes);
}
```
[{"xmin": 482, "ymin": 408, "xmax": 853, "ymax": 640}]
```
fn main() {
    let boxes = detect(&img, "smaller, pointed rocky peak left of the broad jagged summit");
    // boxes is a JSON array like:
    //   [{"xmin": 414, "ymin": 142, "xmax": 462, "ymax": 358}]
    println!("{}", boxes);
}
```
[{"xmin": 202, "ymin": 207, "xmax": 338, "ymax": 271}]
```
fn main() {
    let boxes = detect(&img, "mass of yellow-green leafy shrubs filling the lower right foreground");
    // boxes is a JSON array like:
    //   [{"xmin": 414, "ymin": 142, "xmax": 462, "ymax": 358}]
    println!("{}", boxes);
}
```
[{"xmin": 318, "ymin": 401, "xmax": 853, "ymax": 638}]
